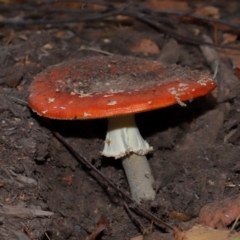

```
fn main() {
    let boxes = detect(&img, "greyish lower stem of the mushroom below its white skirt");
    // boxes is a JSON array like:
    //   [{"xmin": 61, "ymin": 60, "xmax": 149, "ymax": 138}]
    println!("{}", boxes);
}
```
[{"xmin": 122, "ymin": 153, "xmax": 156, "ymax": 203}]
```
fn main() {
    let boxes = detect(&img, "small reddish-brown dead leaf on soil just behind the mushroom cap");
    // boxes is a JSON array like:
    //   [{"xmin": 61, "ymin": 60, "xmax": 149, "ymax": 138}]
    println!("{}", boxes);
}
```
[{"xmin": 130, "ymin": 38, "xmax": 160, "ymax": 54}]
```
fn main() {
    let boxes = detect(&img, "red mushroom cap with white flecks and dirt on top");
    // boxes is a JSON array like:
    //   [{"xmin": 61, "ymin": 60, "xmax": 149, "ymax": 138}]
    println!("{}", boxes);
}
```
[{"xmin": 28, "ymin": 56, "xmax": 216, "ymax": 119}]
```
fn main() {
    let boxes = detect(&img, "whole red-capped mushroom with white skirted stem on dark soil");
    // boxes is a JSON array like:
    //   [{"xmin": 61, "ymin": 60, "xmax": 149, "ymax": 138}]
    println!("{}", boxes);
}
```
[{"xmin": 28, "ymin": 56, "xmax": 216, "ymax": 202}]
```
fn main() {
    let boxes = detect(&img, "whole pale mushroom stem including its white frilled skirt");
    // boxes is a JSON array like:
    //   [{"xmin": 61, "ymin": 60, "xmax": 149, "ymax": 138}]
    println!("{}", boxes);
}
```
[{"xmin": 102, "ymin": 115, "xmax": 156, "ymax": 202}]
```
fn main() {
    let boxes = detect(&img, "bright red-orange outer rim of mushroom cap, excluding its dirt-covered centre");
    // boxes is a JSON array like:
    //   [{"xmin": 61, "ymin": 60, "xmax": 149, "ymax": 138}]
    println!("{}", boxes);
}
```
[{"xmin": 28, "ymin": 57, "xmax": 216, "ymax": 119}]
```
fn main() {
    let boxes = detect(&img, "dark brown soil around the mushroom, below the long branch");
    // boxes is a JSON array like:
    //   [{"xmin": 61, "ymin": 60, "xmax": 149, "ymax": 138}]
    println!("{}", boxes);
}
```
[{"xmin": 0, "ymin": 1, "xmax": 240, "ymax": 240}]
